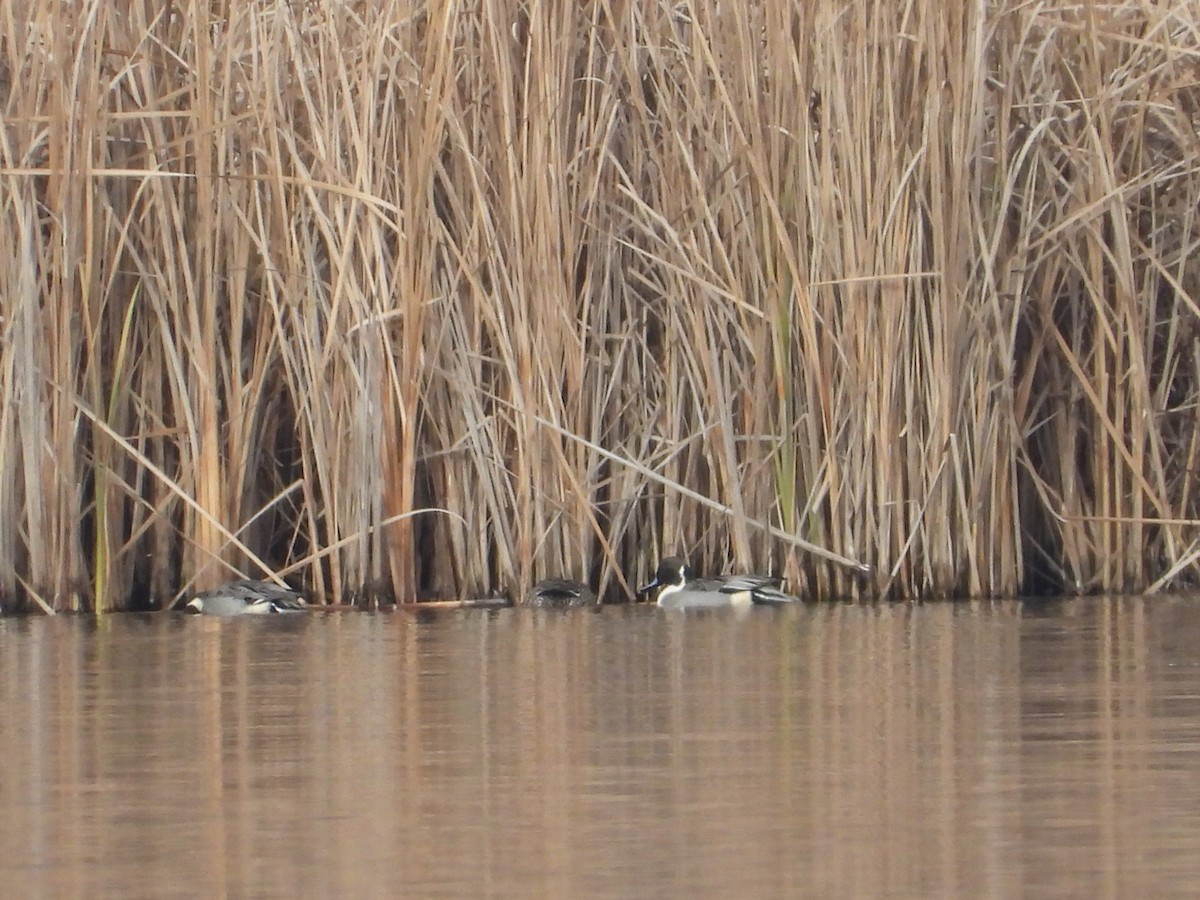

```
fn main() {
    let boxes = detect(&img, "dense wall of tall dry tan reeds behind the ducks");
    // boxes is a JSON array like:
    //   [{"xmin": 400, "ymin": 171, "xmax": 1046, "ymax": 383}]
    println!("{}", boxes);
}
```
[{"xmin": 0, "ymin": 0, "xmax": 1200, "ymax": 611}]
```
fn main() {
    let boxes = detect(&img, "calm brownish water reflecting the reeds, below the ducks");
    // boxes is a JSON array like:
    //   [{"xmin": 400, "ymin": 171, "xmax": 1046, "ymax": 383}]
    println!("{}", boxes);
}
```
[{"xmin": 0, "ymin": 598, "xmax": 1200, "ymax": 898}]
